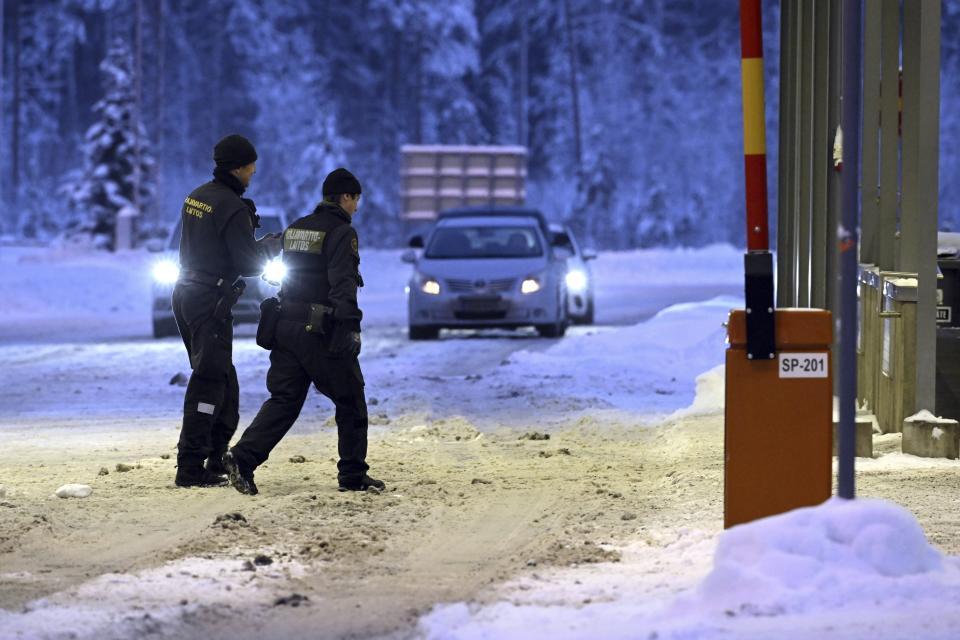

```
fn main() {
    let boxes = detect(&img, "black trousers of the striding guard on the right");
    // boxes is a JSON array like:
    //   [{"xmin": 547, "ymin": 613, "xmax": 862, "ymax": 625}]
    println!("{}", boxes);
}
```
[{"xmin": 231, "ymin": 319, "xmax": 369, "ymax": 483}]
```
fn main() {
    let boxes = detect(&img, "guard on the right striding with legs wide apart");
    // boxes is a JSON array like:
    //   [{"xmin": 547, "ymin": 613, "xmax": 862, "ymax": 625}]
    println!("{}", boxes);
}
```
[{"xmin": 223, "ymin": 169, "xmax": 384, "ymax": 495}]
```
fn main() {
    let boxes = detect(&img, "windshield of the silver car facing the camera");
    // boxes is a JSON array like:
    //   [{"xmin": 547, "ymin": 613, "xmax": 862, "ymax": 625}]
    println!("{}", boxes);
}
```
[{"xmin": 426, "ymin": 226, "xmax": 543, "ymax": 260}]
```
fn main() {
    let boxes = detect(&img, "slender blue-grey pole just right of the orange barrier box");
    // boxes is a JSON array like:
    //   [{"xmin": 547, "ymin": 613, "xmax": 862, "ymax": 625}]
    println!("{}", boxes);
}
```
[{"xmin": 837, "ymin": 0, "xmax": 862, "ymax": 500}]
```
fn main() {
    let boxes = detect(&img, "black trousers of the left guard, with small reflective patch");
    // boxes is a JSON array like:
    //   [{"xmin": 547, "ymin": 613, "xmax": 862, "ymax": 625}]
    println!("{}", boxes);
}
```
[{"xmin": 173, "ymin": 282, "xmax": 240, "ymax": 465}]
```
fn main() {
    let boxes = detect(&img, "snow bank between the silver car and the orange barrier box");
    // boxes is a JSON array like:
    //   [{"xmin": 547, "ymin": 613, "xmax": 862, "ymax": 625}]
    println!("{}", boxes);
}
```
[{"xmin": 503, "ymin": 296, "xmax": 742, "ymax": 414}]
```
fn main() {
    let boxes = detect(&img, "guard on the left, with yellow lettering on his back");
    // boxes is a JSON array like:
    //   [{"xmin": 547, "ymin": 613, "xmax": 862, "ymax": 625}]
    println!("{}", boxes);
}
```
[{"xmin": 173, "ymin": 134, "xmax": 281, "ymax": 487}]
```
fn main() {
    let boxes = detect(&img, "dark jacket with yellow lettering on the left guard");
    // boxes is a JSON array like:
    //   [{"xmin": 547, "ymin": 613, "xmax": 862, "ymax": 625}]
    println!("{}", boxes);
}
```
[{"xmin": 180, "ymin": 172, "xmax": 271, "ymax": 282}]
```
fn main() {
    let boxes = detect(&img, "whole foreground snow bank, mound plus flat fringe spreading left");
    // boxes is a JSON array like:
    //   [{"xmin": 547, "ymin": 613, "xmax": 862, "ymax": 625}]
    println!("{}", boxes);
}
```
[{"xmin": 419, "ymin": 499, "xmax": 960, "ymax": 640}]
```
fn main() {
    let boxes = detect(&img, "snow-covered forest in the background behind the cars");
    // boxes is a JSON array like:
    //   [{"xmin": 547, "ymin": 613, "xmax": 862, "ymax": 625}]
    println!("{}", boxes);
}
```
[{"xmin": 0, "ymin": 0, "xmax": 960, "ymax": 249}]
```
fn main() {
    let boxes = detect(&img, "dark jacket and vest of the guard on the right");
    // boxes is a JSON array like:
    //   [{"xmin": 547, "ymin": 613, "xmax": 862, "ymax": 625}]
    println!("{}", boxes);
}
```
[{"xmin": 280, "ymin": 201, "xmax": 363, "ymax": 331}]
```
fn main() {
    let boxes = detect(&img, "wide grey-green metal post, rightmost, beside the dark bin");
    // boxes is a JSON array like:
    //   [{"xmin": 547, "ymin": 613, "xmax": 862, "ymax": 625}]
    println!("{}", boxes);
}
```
[{"xmin": 900, "ymin": 0, "xmax": 940, "ymax": 411}]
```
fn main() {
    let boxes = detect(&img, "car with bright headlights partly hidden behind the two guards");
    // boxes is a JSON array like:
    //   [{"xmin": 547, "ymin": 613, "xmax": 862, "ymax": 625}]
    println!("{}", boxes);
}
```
[{"xmin": 149, "ymin": 207, "xmax": 287, "ymax": 338}]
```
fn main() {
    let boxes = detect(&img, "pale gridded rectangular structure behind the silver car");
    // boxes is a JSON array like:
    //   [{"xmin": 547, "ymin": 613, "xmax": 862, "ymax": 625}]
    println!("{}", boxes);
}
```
[{"xmin": 400, "ymin": 145, "xmax": 527, "ymax": 222}]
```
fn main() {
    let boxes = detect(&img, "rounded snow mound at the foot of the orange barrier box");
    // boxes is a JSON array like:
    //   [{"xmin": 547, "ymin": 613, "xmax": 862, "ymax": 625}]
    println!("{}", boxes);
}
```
[{"xmin": 692, "ymin": 498, "xmax": 960, "ymax": 615}]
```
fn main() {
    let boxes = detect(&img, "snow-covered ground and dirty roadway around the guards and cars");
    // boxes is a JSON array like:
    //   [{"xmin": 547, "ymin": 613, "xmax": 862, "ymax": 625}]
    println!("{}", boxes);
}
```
[{"xmin": 0, "ymin": 242, "xmax": 960, "ymax": 640}]
